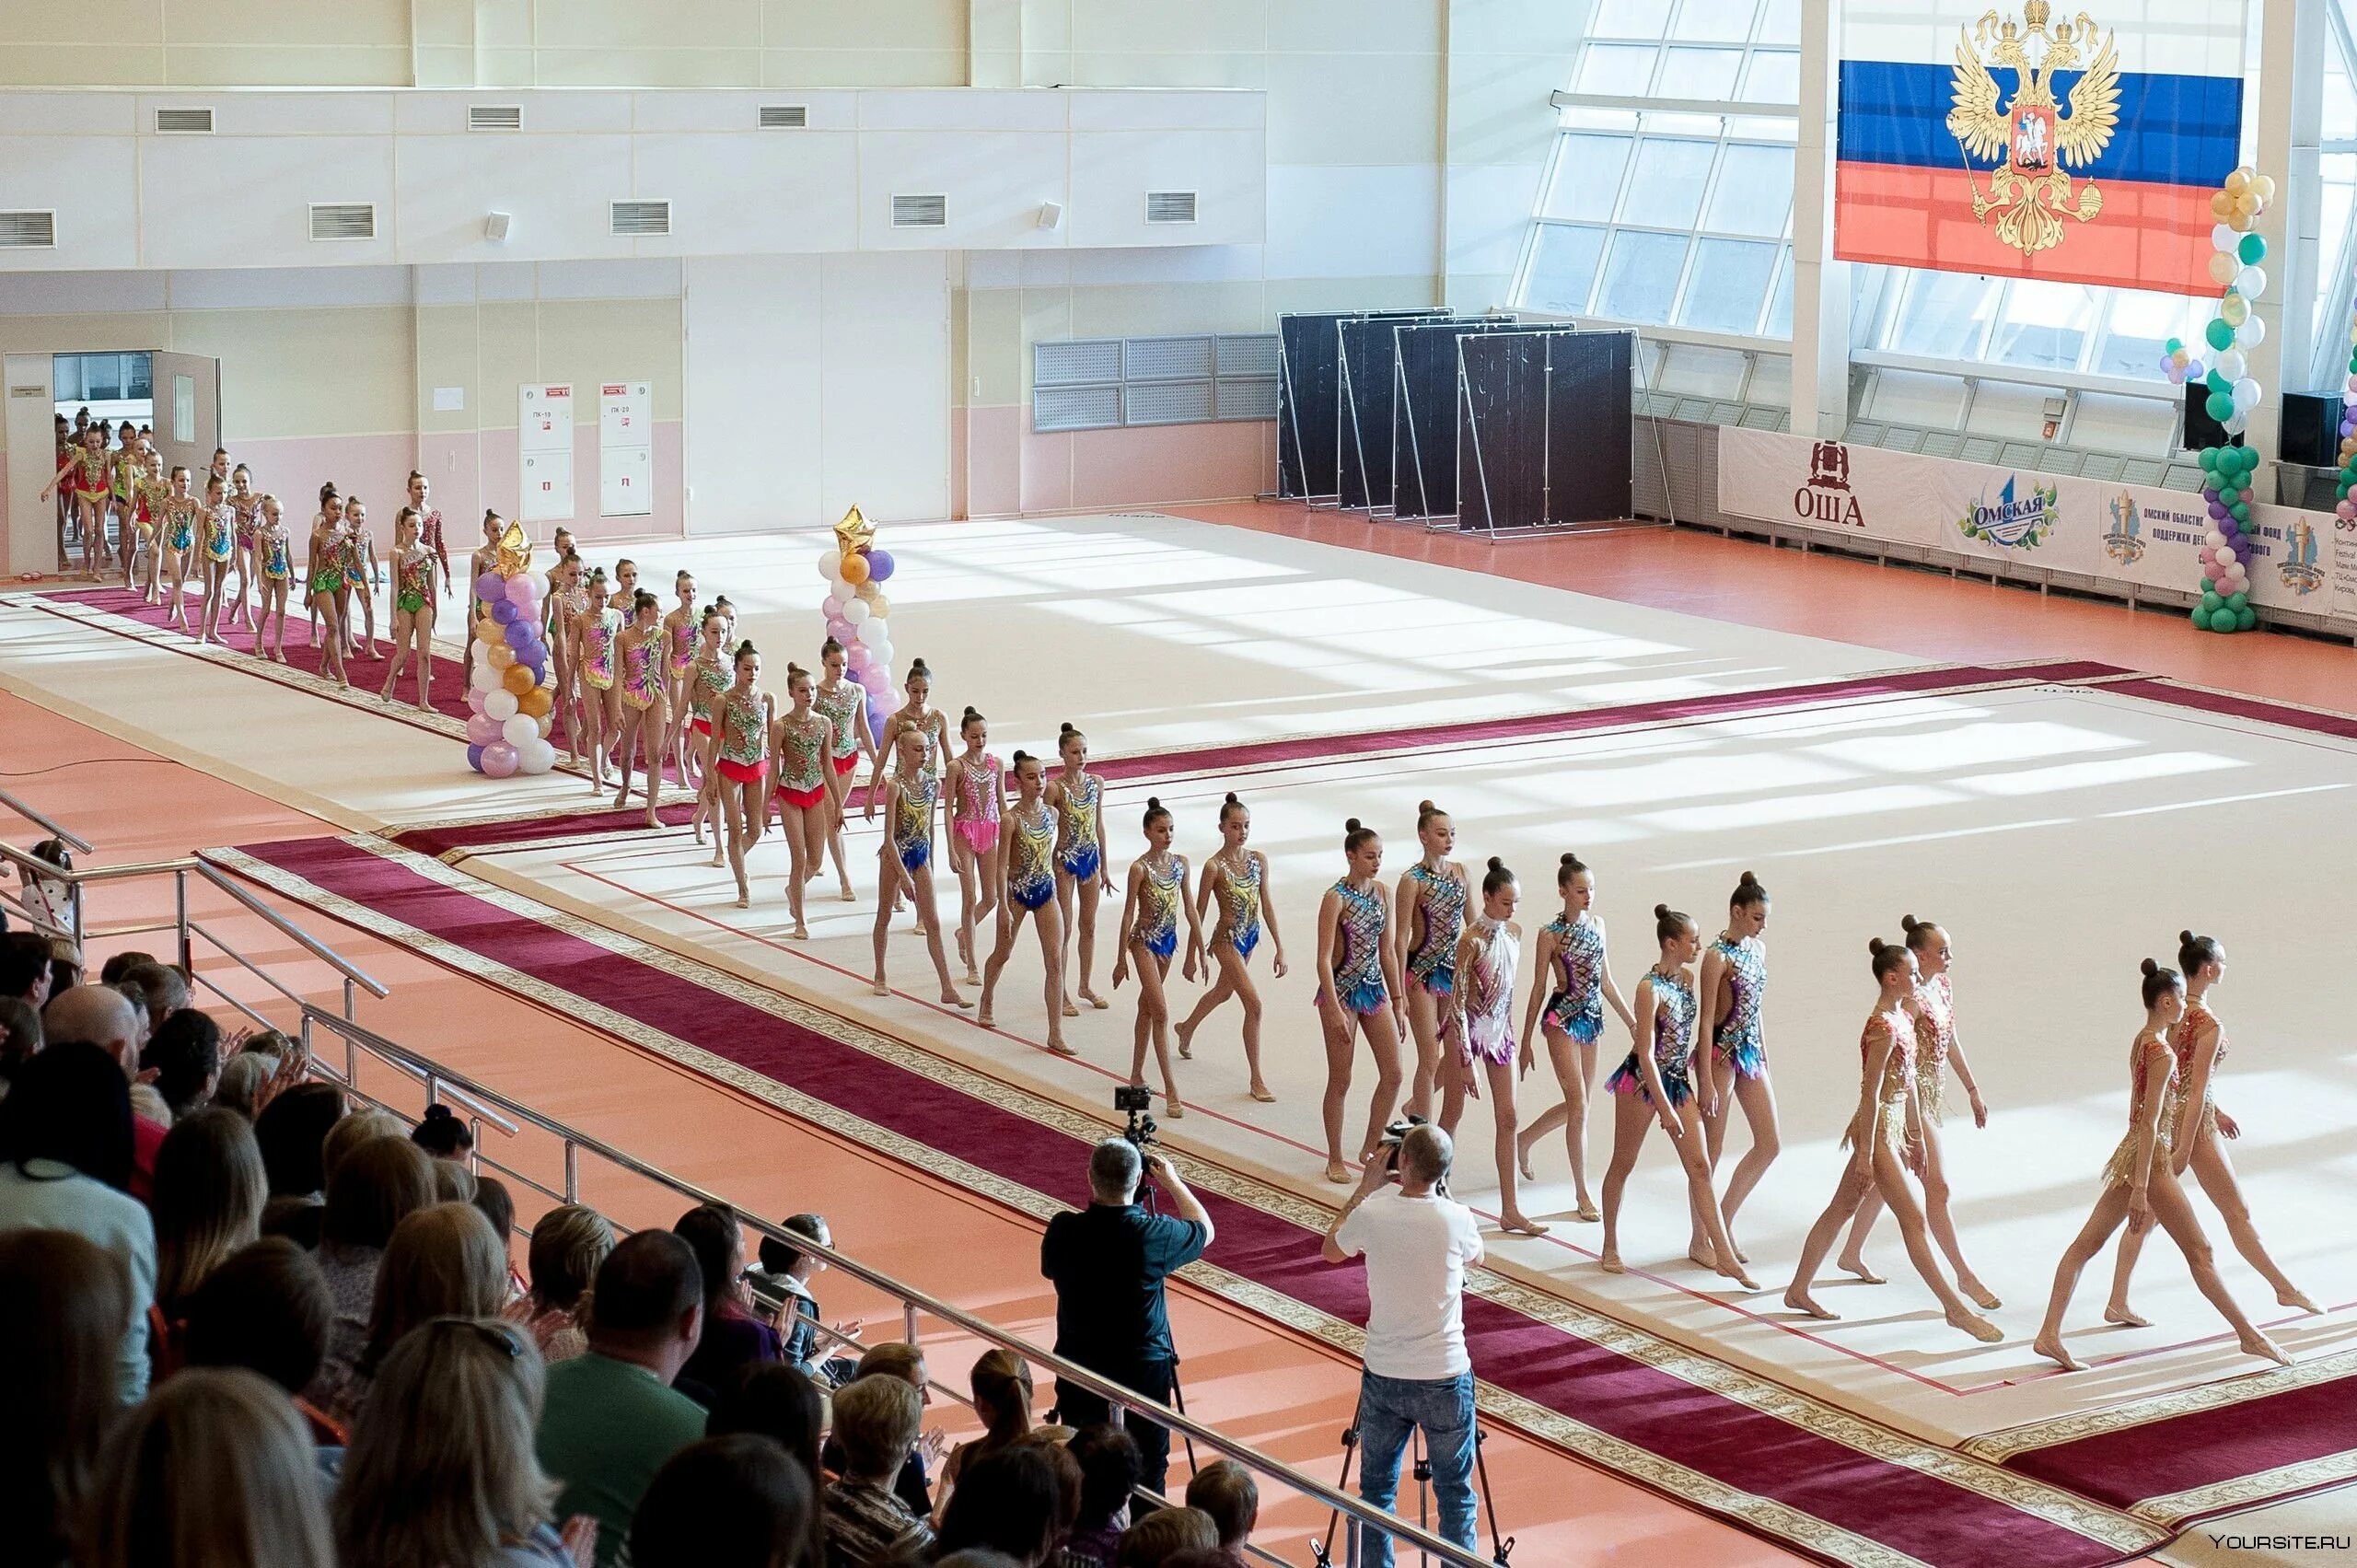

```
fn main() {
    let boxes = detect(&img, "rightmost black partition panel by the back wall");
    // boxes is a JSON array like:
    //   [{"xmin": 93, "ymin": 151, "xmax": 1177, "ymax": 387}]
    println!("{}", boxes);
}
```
[{"xmin": 1457, "ymin": 331, "xmax": 1636, "ymax": 533}]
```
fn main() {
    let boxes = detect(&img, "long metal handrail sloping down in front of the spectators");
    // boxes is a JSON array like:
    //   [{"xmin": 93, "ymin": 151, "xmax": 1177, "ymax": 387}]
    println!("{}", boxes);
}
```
[{"xmin": 284, "ymin": 1002, "xmax": 1487, "ymax": 1568}]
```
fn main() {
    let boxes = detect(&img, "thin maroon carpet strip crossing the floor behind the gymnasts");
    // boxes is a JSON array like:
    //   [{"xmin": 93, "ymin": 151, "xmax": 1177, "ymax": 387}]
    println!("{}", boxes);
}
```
[{"xmin": 389, "ymin": 660, "xmax": 2131, "ymax": 858}]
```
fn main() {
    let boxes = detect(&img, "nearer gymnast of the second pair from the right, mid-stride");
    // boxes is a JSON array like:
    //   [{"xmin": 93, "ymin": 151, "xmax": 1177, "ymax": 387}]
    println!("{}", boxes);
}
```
[{"xmin": 1784, "ymin": 936, "xmax": 2003, "ymax": 1344}]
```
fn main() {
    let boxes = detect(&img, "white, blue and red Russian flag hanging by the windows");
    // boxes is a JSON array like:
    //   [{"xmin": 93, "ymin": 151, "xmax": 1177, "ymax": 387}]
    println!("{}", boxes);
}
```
[{"xmin": 1834, "ymin": 0, "xmax": 2244, "ymax": 295}]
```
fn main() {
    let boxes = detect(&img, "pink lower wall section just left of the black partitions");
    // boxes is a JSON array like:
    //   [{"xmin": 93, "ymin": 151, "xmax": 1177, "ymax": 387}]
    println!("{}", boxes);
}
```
[{"xmin": 950, "ymin": 408, "xmax": 1278, "ymax": 517}]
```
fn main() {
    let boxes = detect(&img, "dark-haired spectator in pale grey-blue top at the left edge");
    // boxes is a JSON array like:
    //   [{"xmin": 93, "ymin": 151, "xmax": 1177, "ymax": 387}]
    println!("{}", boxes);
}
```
[{"xmin": 0, "ymin": 1042, "xmax": 156, "ymax": 1403}]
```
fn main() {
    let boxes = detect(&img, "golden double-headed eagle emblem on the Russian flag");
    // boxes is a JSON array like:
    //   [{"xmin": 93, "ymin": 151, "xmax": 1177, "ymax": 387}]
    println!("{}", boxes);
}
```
[{"xmin": 1947, "ymin": 0, "xmax": 2119, "ymax": 255}]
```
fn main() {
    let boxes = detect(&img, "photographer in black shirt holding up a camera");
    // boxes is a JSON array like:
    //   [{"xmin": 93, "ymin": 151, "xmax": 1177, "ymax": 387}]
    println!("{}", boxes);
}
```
[{"xmin": 1039, "ymin": 1139, "xmax": 1212, "ymax": 1493}]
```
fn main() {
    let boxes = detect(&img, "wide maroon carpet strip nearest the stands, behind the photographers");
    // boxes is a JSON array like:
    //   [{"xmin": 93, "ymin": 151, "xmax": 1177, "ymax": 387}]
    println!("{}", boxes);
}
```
[{"xmin": 225, "ymin": 840, "xmax": 2158, "ymax": 1568}]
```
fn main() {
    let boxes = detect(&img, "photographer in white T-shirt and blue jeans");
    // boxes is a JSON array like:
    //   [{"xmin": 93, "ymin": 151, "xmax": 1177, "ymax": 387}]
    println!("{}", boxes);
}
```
[{"xmin": 1325, "ymin": 1125, "xmax": 1482, "ymax": 1568}]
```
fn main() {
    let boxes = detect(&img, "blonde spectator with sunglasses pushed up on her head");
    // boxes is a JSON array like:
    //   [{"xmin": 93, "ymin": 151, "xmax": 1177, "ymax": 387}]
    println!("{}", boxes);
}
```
[{"xmin": 332, "ymin": 1310, "xmax": 589, "ymax": 1568}]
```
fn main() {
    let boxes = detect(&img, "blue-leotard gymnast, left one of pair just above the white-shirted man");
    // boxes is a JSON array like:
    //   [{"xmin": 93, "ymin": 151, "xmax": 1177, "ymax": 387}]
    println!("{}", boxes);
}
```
[{"xmin": 1318, "ymin": 816, "xmax": 1400, "ymax": 1186}]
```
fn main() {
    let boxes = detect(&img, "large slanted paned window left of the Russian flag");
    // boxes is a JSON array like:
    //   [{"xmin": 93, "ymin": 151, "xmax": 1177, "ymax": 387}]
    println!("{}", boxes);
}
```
[{"xmin": 1514, "ymin": 0, "xmax": 1801, "ymax": 337}]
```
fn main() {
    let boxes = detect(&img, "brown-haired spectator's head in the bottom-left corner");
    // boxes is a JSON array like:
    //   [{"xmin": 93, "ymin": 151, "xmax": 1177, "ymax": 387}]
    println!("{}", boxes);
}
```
[{"xmin": 0, "ymin": 1231, "xmax": 132, "ymax": 1568}]
